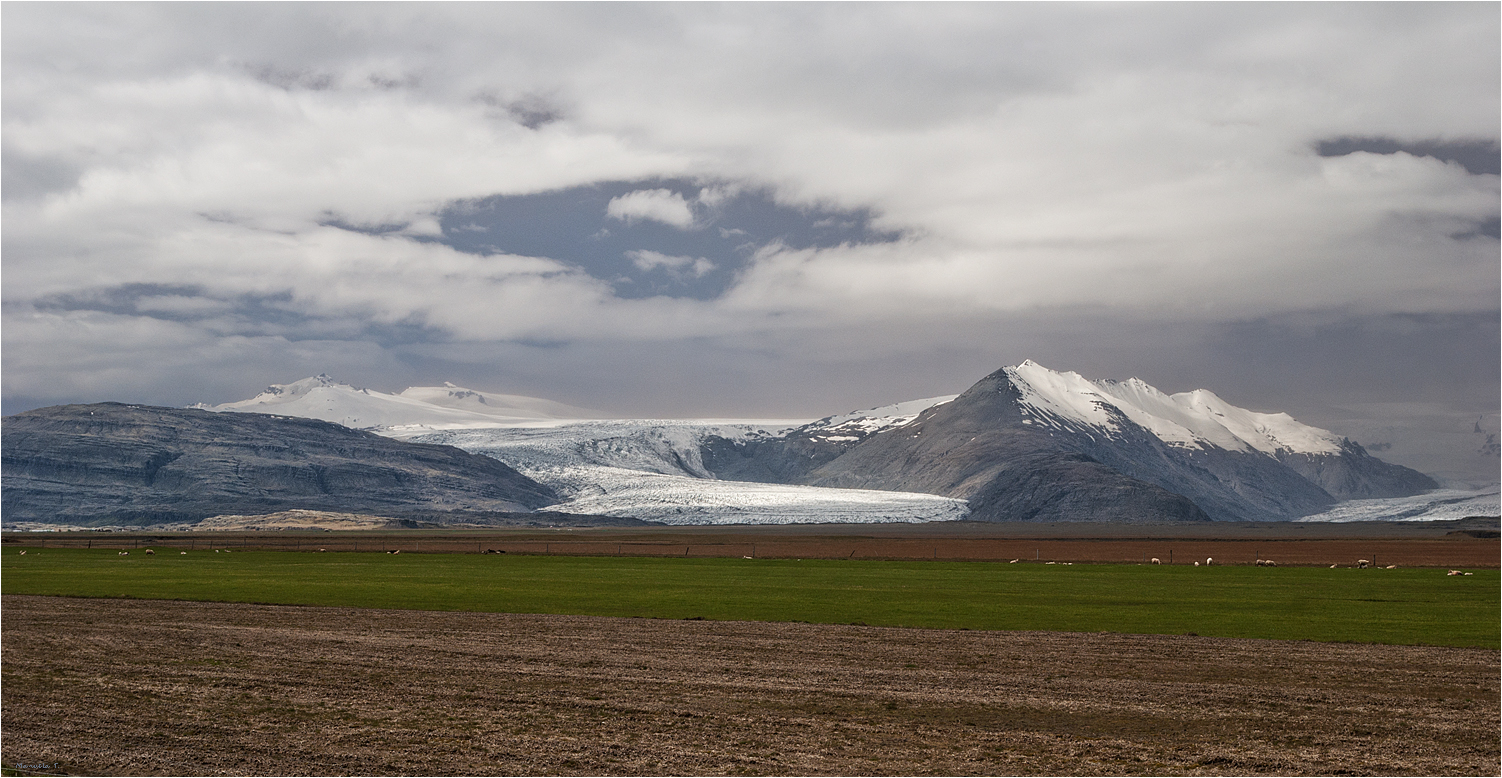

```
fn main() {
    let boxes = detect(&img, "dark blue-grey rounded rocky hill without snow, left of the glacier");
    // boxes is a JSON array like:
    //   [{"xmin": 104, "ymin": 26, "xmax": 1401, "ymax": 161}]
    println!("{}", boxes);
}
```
[{"xmin": 0, "ymin": 403, "xmax": 557, "ymax": 524}]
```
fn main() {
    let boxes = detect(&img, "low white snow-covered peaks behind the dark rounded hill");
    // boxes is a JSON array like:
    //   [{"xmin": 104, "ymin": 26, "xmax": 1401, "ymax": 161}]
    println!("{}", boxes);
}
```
[{"xmin": 194, "ymin": 374, "xmax": 601, "ymax": 433}]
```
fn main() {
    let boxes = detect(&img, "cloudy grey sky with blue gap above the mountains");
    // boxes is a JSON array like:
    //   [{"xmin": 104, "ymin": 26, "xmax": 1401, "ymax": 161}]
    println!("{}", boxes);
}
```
[{"xmin": 0, "ymin": 2, "xmax": 1502, "ymax": 481}]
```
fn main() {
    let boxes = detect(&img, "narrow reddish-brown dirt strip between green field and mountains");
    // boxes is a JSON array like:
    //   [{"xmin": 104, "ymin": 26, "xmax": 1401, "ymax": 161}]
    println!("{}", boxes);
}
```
[{"xmin": 5, "ymin": 520, "xmax": 1502, "ymax": 568}]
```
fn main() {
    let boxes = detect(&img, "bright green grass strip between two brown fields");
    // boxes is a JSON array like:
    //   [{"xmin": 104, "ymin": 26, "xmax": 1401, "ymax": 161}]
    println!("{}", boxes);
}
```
[{"xmin": 0, "ymin": 548, "xmax": 1502, "ymax": 649}]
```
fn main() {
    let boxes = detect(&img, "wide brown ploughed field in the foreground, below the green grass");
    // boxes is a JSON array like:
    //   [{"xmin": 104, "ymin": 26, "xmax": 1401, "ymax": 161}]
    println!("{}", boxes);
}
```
[{"xmin": 0, "ymin": 595, "xmax": 1502, "ymax": 775}]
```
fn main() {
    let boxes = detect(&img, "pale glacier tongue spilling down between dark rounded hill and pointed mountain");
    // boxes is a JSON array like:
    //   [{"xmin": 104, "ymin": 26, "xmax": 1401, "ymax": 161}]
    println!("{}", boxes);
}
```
[{"xmin": 404, "ymin": 419, "xmax": 969, "ymax": 524}]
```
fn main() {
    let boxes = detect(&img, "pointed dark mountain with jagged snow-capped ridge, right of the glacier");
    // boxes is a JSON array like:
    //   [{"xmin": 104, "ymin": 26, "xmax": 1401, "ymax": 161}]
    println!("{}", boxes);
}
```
[{"xmin": 706, "ymin": 360, "xmax": 1436, "ymax": 521}]
